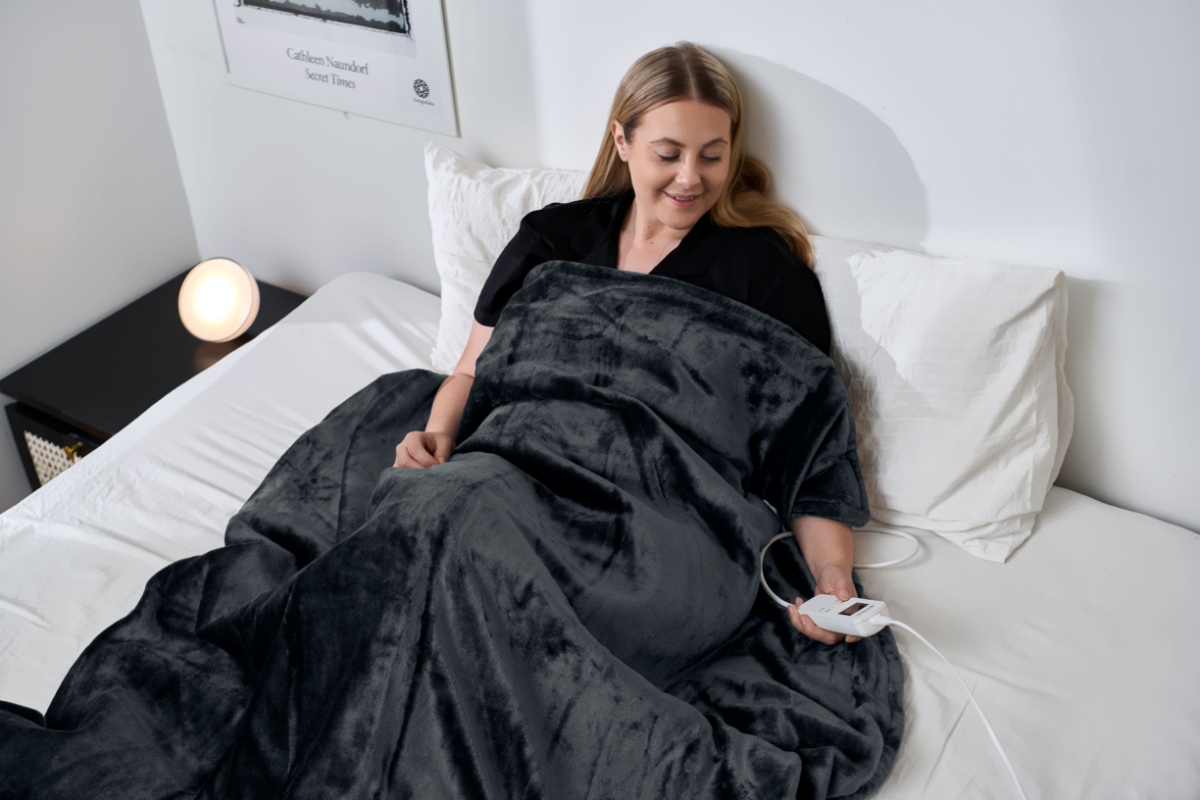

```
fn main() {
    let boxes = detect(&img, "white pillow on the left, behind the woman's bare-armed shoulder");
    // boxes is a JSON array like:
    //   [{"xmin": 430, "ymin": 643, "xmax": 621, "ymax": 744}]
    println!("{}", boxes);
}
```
[{"xmin": 425, "ymin": 142, "xmax": 587, "ymax": 373}]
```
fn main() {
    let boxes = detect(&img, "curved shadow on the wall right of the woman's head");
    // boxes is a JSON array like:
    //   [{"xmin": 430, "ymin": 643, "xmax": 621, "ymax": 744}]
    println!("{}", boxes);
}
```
[{"xmin": 706, "ymin": 46, "xmax": 929, "ymax": 249}]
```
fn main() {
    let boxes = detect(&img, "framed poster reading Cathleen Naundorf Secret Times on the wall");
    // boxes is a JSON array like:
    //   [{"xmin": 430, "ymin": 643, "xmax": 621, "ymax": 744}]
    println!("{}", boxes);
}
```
[{"xmin": 214, "ymin": 0, "xmax": 458, "ymax": 136}]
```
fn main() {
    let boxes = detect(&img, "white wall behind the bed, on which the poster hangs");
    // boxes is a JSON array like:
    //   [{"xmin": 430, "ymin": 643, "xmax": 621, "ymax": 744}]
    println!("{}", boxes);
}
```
[{"xmin": 142, "ymin": 0, "xmax": 1200, "ymax": 537}]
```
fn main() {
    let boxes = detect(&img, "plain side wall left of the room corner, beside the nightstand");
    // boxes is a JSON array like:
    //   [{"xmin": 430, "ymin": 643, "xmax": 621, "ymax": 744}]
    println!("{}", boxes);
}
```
[{"xmin": 0, "ymin": 0, "xmax": 197, "ymax": 511}]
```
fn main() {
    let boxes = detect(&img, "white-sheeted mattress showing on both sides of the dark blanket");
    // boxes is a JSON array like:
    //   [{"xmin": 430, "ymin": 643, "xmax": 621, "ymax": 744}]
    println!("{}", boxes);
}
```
[{"xmin": 0, "ymin": 273, "xmax": 1200, "ymax": 800}]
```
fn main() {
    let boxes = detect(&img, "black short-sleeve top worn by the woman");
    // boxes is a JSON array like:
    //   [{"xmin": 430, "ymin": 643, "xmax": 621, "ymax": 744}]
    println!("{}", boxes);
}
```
[{"xmin": 475, "ymin": 191, "xmax": 829, "ymax": 355}]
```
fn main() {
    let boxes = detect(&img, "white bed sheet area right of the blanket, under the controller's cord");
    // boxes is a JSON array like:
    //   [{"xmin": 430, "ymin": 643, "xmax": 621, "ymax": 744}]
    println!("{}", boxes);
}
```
[{"xmin": 859, "ymin": 487, "xmax": 1200, "ymax": 800}]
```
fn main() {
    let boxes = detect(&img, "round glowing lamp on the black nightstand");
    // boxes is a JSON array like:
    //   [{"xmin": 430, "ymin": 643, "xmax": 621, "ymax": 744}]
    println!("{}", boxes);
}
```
[{"xmin": 179, "ymin": 258, "xmax": 258, "ymax": 342}]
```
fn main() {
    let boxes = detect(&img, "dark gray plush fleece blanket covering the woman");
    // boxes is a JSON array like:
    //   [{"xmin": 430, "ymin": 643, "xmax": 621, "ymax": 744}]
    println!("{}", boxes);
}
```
[{"xmin": 0, "ymin": 263, "xmax": 904, "ymax": 800}]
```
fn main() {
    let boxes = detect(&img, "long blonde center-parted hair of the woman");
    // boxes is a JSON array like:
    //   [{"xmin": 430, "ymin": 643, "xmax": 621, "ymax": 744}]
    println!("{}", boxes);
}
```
[{"xmin": 583, "ymin": 42, "xmax": 812, "ymax": 266}]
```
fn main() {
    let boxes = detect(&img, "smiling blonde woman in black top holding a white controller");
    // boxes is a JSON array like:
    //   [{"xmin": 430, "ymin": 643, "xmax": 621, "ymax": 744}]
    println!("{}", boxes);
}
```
[{"xmin": 395, "ymin": 43, "xmax": 858, "ymax": 644}]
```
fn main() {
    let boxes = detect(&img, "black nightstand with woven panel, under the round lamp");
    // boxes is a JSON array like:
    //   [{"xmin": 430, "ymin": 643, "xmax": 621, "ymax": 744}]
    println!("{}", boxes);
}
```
[{"xmin": 0, "ymin": 272, "xmax": 305, "ymax": 489}]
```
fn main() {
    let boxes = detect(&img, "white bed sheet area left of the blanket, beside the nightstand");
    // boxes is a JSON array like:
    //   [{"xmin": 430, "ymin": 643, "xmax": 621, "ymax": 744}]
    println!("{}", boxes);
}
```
[{"xmin": 0, "ymin": 272, "xmax": 439, "ymax": 710}]
